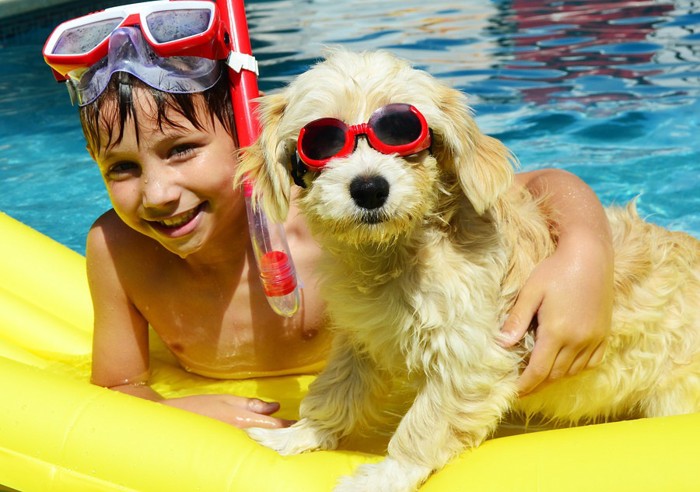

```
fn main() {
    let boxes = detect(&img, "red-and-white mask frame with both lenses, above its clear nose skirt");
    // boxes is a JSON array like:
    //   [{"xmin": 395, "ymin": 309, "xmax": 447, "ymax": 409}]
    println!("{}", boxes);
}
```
[{"xmin": 44, "ymin": 0, "xmax": 224, "ymax": 80}]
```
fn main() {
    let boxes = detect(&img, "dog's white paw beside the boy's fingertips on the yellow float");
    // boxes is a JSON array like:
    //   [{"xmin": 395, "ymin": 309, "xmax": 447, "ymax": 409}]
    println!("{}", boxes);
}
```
[{"xmin": 246, "ymin": 419, "xmax": 338, "ymax": 456}]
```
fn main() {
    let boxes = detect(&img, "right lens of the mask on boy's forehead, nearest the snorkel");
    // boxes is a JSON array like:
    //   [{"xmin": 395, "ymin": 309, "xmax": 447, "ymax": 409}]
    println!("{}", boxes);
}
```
[{"xmin": 146, "ymin": 9, "xmax": 211, "ymax": 43}]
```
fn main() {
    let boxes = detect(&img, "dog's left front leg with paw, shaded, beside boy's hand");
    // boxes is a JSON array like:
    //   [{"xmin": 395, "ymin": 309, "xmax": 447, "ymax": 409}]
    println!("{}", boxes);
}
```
[{"xmin": 247, "ymin": 336, "xmax": 383, "ymax": 455}]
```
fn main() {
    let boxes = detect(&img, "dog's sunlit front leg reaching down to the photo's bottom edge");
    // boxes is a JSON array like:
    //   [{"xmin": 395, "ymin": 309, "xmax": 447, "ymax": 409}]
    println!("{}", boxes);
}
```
[{"xmin": 335, "ymin": 343, "xmax": 517, "ymax": 492}]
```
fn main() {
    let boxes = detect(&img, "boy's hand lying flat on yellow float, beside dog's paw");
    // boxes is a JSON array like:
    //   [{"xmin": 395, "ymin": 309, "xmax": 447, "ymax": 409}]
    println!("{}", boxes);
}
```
[{"xmin": 162, "ymin": 395, "xmax": 294, "ymax": 429}]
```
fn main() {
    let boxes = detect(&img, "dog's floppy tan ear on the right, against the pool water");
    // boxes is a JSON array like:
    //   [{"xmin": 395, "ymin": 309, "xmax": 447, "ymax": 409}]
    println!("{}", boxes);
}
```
[{"xmin": 433, "ymin": 86, "xmax": 516, "ymax": 214}]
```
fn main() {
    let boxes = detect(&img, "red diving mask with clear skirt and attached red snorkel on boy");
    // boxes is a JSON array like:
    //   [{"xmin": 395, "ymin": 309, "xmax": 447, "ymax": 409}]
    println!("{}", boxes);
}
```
[{"xmin": 43, "ymin": 0, "xmax": 300, "ymax": 317}]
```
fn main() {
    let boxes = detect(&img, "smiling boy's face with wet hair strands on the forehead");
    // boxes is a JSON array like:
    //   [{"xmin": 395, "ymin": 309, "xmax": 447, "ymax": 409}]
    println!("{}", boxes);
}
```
[{"xmin": 93, "ymin": 89, "xmax": 241, "ymax": 258}]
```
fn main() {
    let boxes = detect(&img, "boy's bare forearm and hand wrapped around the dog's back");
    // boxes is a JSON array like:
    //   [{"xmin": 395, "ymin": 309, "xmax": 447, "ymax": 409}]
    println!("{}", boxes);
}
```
[{"xmin": 502, "ymin": 169, "xmax": 613, "ymax": 395}]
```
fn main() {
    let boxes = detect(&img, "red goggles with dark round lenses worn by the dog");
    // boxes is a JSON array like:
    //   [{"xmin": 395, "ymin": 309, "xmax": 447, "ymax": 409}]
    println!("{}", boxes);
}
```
[{"xmin": 297, "ymin": 103, "xmax": 431, "ymax": 171}]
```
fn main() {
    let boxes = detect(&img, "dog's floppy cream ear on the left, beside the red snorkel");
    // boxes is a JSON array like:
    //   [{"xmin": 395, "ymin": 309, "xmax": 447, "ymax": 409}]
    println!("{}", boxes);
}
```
[{"xmin": 234, "ymin": 94, "xmax": 293, "ymax": 222}]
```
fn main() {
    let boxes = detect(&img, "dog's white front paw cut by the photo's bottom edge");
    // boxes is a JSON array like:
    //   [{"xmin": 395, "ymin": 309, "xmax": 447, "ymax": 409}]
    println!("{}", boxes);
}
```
[{"xmin": 333, "ymin": 458, "xmax": 432, "ymax": 492}]
